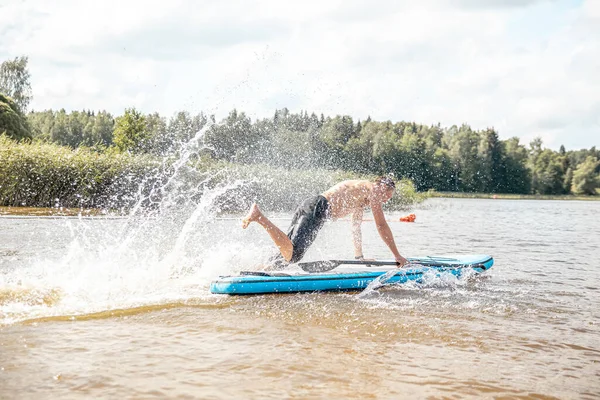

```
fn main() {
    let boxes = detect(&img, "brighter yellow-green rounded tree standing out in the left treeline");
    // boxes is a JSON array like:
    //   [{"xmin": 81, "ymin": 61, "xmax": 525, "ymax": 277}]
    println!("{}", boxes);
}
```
[{"xmin": 113, "ymin": 108, "xmax": 151, "ymax": 153}]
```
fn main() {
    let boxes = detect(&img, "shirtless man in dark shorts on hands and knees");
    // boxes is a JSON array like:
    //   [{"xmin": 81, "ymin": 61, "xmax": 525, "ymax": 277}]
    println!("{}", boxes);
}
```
[{"xmin": 242, "ymin": 176, "xmax": 408, "ymax": 269}]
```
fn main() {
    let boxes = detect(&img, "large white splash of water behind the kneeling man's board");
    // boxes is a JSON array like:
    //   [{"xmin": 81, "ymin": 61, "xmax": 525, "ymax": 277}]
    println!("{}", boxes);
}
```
[{"xmin": 0, "ymin": 125, "xmax": 265, "ymax": 323}]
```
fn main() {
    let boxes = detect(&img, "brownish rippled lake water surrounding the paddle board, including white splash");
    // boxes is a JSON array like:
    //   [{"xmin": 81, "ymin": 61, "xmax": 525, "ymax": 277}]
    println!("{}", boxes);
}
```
[{"xmin": 0, "ymin": 199, "xmax": 600, "ymax": 399}]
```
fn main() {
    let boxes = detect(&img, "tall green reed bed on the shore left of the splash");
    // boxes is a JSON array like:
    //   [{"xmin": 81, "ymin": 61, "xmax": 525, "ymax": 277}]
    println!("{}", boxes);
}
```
[{"xmin": 0, "ymin": 135, "xmax": 156, "ymax": 208}]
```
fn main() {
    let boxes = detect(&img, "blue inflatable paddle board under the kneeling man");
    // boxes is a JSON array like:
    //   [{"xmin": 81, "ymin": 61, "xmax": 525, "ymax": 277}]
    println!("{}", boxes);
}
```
[{"xmin": 210, "ymin": 255, "xmax": 494, "ymax": 295}]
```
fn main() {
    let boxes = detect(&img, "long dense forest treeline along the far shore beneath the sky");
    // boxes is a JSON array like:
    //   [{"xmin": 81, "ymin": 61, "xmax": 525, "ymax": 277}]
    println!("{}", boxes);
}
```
[{"xmin": 15, "ymin": 108, "xmax": 600, "ymax": 194}]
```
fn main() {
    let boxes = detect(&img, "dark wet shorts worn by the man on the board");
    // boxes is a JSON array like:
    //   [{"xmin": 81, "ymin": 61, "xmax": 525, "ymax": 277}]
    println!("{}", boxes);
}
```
[{"xmin": 270, "ymin": 195, "xmax": 330, "ymax": 269}]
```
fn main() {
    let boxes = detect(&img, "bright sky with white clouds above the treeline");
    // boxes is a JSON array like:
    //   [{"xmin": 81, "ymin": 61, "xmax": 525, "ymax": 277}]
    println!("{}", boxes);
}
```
[{"xmin": 0, "ymin": 0, "xmax": 600, "ymax": 150}]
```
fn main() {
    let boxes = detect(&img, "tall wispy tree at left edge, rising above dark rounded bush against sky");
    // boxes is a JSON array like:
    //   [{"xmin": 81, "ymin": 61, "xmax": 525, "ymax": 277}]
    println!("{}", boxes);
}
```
[{"xmin": 0, "ymin": 57, "xmax": 33, "ymax": 113}]
